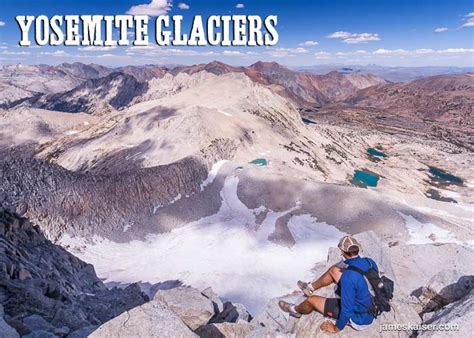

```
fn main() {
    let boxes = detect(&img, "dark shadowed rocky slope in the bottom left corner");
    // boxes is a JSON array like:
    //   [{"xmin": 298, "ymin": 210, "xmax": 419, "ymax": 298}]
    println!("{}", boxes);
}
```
[{"xmin": 0, "ymin": 206, "xmax": 148, "ymax": 337}]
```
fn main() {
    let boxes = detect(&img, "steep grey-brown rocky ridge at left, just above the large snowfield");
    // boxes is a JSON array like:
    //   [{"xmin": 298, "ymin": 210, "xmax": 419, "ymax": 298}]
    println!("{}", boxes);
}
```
[{"xmin": 0, "ymin": 149, "xmax": 212, "ymax": 239}]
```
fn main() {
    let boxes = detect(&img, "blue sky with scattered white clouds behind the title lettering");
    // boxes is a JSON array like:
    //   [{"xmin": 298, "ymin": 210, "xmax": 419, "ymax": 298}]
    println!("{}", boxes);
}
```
[{"xmin": 0, "ymin": 0, "xmax": 474, "ymax": 66}]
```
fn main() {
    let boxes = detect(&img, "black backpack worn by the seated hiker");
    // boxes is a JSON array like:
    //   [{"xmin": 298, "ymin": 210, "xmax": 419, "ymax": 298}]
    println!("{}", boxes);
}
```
[{"xmin": 347, "ymin": 258, "xmax": 394, "ymax": 318}]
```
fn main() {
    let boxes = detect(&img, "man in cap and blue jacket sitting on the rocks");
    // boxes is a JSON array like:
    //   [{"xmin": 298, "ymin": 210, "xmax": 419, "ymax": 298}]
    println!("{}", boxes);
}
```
[{"xmin": 279, "ymin": 236, "xmax": 384, "ymax": 333}]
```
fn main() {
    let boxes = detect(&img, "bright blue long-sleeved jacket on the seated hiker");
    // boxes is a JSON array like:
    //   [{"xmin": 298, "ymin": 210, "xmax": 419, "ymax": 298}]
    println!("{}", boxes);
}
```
[{"xmin": 336, "ymin": 257, "xmax": 379, "ymax": 330}]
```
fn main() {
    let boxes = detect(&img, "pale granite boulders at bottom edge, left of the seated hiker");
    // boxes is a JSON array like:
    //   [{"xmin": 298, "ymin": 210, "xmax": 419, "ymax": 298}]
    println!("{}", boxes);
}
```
[{"xmin": 91, "ymin": 286, "xmax": 259, "ymax": 338}]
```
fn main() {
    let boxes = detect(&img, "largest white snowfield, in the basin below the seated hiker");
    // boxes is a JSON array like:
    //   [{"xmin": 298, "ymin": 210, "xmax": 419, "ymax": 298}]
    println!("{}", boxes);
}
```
[{"xmin": 61, "ymin": 176, "xmax": 344, "ymax": 313}]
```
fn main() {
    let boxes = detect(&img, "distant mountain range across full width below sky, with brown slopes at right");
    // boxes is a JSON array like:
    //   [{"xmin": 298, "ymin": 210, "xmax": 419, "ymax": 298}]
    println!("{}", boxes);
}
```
[{"xmin": 0, "ymin": 61, "xmax": 474, "ymax": 136}]
